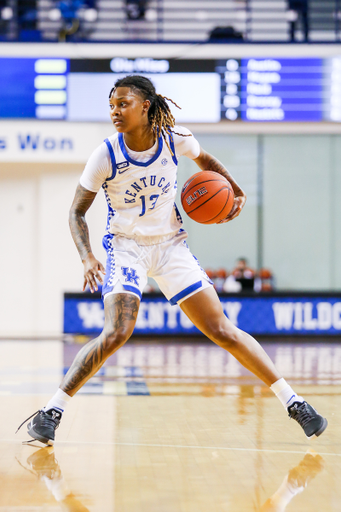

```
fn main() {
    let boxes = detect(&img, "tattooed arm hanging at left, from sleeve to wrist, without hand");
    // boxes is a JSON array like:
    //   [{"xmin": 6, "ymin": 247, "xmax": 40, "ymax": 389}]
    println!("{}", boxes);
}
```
[{"xmin": 69, "ymin": 185, "xmax": 96, "ymax": 260}]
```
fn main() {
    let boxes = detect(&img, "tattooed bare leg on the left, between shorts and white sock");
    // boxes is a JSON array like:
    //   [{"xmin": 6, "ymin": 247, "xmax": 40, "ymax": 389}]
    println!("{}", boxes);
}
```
[{"xmin": 60, "ymin": 293, "xmax": 140, "ymax": 396}]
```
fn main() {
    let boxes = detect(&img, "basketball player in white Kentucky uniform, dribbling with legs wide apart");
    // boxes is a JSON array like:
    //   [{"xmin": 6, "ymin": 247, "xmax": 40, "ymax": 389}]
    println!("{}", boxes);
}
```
[{"xmin": 19, "ymin": 75, "xmax": 327, "ymax": 444}]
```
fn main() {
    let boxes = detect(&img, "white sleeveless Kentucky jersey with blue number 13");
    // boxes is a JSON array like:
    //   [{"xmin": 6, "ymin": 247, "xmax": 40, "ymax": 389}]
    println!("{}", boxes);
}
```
[{"xmin": 102, "ymin": 133, "xmax": 182, "ymax": 237}]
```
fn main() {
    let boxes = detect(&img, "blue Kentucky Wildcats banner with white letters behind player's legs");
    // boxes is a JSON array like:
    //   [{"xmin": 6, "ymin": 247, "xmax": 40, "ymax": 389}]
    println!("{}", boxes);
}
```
[{"xmin": 64, "ymin": 293, "xmax": 341, "ymax": 335}]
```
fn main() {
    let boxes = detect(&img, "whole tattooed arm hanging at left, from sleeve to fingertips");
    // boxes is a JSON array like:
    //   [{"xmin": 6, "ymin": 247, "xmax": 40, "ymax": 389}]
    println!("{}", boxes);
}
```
[{"xmin": 69, "ymin": 184, "xmax": 105, "ymax": 293}]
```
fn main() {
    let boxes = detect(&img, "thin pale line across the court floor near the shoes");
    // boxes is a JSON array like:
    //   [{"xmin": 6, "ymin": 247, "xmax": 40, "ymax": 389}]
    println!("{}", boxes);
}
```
[{"xmin": 0, "ymin": 439, "xmax": 341, "ymax": 457}]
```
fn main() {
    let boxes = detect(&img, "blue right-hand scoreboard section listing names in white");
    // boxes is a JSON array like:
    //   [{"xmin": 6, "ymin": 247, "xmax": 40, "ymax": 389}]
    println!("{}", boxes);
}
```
[{"xmin": 217, "ymin": 57, "xmax": 341, "ymax": 122}]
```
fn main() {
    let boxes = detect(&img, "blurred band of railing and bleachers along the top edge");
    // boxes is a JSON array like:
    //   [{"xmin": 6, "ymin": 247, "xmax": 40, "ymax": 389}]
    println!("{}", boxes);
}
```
[{"xmin": 0, "ymin": 0, "xmax": 341, "ymax": 43}]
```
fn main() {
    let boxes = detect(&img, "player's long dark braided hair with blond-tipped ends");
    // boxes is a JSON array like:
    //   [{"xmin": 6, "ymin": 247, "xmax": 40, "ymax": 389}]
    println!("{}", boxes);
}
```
[{"xmin": 109, "ymin": 75, "xmax": 191, "ymax": 156}]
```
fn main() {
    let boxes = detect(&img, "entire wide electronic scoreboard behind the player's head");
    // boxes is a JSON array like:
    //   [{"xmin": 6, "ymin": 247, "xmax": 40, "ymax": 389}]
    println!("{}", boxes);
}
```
[{"xmin": 0, "ymin": 55, "xmax": 341, "ymax": 123}]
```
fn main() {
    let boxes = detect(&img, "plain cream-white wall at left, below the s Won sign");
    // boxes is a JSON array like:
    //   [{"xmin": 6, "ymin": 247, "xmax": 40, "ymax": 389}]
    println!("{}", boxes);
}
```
[{"xmin": 0, "ymin": 164, "xmax": 106, "ymax": 337}]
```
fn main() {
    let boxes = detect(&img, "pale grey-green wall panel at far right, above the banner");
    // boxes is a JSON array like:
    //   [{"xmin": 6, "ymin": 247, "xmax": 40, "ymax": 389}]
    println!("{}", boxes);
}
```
[{"xmin": 264, "ymin": 135, "xmax": 332, "ymax": 290}]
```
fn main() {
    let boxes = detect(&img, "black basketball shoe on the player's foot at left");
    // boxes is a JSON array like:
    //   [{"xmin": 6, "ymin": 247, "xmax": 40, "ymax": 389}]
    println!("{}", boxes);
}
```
[{"xmin": 17, "ymin": 409, "xmax": 62, "ymax": 445}]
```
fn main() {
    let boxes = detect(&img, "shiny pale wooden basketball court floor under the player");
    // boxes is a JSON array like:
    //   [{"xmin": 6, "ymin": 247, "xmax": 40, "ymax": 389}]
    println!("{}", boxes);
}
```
[{"xmin": 0, "ymin": 339, "xmax": 341, "ymax": 512}]
